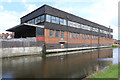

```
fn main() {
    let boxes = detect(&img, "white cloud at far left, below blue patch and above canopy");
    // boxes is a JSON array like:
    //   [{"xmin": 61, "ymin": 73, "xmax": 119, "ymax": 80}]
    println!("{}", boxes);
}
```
[{"xmin": 0, "ymin": 11, "xmax": 19, "ymax": 33}]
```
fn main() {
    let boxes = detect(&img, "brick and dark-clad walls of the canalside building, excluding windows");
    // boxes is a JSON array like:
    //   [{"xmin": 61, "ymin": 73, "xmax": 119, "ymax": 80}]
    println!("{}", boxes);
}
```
[{"xmin": 18, "ymin": 5, "xmax": 113, "ymax": 48}]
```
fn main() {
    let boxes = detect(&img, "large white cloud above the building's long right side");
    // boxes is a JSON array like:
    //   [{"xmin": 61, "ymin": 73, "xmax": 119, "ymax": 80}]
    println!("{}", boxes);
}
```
[{"xmin": 55, "ymin": 0, "xmax": 119, "ymax": 39}]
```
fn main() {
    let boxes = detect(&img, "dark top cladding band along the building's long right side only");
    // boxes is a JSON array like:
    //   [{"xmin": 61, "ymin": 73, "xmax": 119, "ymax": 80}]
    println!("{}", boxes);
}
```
[{"xmin": 45, "ymin": 5, "xmax": 113, "ymax": 32}]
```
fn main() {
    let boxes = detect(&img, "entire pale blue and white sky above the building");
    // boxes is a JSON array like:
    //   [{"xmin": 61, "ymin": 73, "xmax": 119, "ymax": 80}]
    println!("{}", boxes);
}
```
[{"xmin": 0, "ymin": 0, "xmax": 119, "ymax": 39}]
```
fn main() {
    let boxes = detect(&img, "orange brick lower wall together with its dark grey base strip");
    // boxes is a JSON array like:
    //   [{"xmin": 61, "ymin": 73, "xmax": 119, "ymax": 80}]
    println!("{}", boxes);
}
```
[{"xmin": 44, "ymin": 29, "xmax": 113, "ymax": 48}]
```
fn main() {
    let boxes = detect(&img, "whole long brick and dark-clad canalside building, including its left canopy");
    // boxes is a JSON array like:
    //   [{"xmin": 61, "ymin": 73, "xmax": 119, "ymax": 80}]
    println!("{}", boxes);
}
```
[{"xmin": 7, "ymin": 5, "xmax": 113, "ymax": 49}]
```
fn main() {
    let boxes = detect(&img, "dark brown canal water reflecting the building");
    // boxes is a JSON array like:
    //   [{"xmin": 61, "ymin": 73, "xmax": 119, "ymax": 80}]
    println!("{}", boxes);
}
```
[{"xmin": 2, "ymin": 48, "xmax": 118, "ymax": 78}]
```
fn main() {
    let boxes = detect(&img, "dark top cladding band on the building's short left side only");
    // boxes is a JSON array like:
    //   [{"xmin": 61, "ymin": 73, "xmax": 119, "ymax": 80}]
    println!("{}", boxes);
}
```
[{"xmin": 21, "ymin": 6, "xmax": 45, "ymax": 23}]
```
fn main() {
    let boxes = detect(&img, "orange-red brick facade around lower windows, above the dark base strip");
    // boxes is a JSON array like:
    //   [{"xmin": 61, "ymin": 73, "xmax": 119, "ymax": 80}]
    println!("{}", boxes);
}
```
[{"xmin": 45, "ymin": 29, "xmax": 113, "ymax": 44}]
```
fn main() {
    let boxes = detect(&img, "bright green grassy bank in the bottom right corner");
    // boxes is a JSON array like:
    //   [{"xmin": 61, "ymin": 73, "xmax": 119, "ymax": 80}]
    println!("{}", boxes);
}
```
[{"xmin": 88, "ymin": 64, "xmax": 120, "ymax": 78}]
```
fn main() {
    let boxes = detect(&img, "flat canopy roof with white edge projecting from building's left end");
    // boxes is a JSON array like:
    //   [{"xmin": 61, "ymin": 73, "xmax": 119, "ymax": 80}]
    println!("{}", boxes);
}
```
[{"xmin": 6, "ymin": 23, "xmax": 44, "ymax": 32}]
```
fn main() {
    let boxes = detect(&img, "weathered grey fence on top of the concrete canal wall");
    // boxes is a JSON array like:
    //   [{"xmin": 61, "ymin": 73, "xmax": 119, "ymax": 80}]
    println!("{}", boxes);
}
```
[{"xmin": 0, "ymin": 38, "xmax": 43, "ymax": 48}]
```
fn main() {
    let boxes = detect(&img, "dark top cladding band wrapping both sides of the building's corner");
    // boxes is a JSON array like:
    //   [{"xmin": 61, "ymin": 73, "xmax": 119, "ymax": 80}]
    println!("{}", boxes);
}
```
[{"xmin": 21, "ymin": 5, "xmax": 113, "ymax": 32}]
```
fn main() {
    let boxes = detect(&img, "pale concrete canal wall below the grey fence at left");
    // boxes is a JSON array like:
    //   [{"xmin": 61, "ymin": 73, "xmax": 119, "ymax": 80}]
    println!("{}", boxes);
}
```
[{"xmin": 0, "ymin": 47, "xmax": 42, "ymax": 58}]
